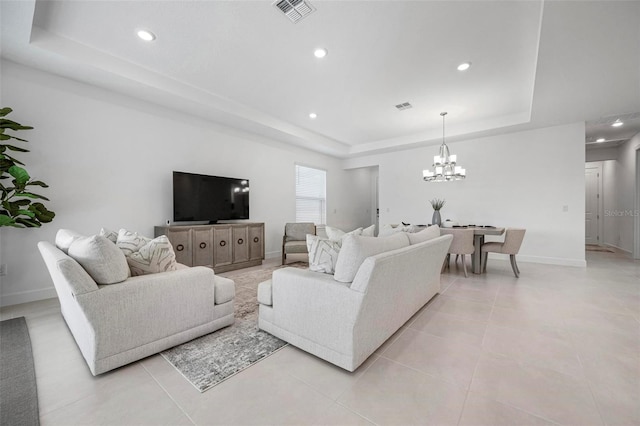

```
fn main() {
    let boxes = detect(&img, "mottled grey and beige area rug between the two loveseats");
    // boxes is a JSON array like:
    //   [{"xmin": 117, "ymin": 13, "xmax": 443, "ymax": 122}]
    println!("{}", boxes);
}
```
[{"xmin": 162, "ymin": 262, "xmax": 308, "ymax": 392}]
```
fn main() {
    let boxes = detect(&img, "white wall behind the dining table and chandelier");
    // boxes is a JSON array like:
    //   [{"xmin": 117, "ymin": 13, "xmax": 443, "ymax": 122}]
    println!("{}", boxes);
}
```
[{"xmin": 346, "ymin": 123, "xmax": 586, "ymax": 266}]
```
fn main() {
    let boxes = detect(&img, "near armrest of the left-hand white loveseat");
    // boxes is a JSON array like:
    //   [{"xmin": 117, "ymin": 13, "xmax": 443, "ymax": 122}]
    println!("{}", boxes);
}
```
[{"xmin": 76, "ymin": 267, "xmax": 215, "ymax": 357}]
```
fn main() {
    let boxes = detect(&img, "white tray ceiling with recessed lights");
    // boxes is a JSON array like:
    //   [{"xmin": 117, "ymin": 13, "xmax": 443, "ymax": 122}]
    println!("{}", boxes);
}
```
[{"xmin": 0, "ymin": 0, "xmax": 640, "ymax": 157}]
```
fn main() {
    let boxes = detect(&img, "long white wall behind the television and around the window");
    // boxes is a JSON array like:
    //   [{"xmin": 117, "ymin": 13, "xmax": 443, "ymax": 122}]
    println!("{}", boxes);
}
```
[{"xmin": 0, "ymin": 61, "xmax": 371, "ymax": 305}]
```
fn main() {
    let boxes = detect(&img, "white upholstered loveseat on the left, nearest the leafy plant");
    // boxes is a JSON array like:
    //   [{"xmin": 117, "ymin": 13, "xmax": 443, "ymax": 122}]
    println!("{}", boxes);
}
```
[{"xmin": 38, "ymin": 230, "xmax": 235, "ymax": 375}]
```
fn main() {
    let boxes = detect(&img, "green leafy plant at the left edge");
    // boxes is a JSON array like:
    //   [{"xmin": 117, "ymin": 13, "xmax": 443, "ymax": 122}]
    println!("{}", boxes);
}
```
[{"xmin": 0, "ymin": 108, "xmax": 56, "ymax": 228}]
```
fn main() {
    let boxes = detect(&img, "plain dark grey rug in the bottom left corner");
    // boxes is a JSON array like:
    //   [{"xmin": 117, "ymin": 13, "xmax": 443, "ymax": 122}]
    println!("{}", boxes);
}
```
[{"xmin": 0, "ymin": 317, "xmax": 40, "ymax": 425}]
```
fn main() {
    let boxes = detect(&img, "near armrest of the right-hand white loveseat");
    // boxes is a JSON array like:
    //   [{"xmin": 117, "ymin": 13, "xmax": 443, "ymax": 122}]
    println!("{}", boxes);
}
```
[{"xmin": 272, "ymin": 268, "xmax": 363, "ymax": 353}]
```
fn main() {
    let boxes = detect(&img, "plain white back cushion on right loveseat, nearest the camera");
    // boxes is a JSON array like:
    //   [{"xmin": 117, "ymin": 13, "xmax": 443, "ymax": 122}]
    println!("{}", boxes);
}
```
[{"xmin": 333, "ymin": 232, "xmax": 409, "ymax": 283}]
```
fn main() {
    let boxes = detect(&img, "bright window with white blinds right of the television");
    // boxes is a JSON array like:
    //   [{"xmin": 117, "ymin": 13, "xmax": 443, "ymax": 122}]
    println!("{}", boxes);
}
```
[{"xmin": 296, "ymin": 165, "xmax": 327, "ymax": 225}]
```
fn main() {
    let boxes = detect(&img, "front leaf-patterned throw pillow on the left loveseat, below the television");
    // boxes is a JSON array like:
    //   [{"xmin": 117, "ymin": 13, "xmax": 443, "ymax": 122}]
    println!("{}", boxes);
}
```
[{"xmin": 127, "ymin": 235, "xmax": 177, "ymax": 277}]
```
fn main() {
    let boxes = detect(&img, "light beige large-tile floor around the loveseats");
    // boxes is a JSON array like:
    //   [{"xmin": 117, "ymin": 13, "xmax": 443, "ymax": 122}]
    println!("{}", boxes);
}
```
[{"xmin": 0, "ymin": 252, "xmax": 640, "ymax": 425}]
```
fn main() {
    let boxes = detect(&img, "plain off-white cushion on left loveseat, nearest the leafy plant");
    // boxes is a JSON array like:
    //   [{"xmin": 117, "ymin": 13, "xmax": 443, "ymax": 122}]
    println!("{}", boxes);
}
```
[{"xmin": 69, "ymin": 235, "xmax": 129, "ymax": 284}]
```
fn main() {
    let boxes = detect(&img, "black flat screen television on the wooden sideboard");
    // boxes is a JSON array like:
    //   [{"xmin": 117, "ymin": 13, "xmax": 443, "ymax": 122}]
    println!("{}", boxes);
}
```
[{"xmin": 173, "ymin": 171, "xmax": 249, "ymax": 223}]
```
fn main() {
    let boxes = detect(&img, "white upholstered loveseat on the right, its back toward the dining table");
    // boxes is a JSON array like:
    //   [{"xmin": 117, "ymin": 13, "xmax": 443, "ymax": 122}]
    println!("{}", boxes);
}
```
[{"xmin": 258, "ymin": 230, "xmax": 453, "ymax": 371}]
